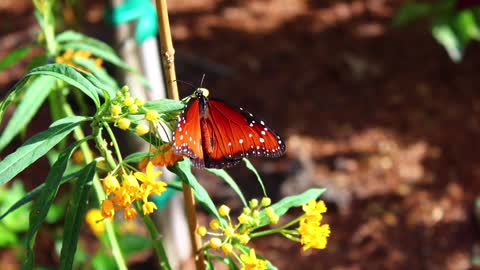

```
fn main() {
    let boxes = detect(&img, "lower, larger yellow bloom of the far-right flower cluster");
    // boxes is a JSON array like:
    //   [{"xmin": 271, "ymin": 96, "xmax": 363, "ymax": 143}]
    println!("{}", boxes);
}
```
[{"xmin": 298, "ymin": 219, "xmax": 330, "ymax": 250}]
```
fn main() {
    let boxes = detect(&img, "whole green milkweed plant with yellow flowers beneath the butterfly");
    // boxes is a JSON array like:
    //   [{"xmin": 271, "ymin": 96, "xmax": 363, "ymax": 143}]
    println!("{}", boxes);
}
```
[{"xmin": 0, "ymin": 0, "xmax": 330, "ymax": 269}]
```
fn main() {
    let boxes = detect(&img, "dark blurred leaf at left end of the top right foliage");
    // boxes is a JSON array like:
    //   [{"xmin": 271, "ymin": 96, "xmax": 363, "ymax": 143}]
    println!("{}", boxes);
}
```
[{"xmin": 393, "ymin": 2, "xmax": 434, "ymax": 26}]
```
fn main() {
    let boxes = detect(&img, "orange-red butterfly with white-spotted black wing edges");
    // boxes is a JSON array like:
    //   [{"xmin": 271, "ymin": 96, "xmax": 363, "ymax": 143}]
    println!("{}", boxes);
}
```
[{"xmin": 173, "ymin": 88, "xmax": 285, "ymax": 168}]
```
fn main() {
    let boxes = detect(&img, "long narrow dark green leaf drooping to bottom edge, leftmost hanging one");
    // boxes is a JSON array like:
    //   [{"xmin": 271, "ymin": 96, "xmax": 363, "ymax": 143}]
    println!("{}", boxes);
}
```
[{"xmin": 22, "ymin": 140, "xmax": 85, "ymax": 269}]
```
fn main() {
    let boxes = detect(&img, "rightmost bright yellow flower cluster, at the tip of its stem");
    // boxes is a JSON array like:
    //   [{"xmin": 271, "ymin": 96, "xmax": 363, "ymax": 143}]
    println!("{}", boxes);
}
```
[{"xmin": 298, "ymin": 200, "xmax": 330, "ymax": 250}]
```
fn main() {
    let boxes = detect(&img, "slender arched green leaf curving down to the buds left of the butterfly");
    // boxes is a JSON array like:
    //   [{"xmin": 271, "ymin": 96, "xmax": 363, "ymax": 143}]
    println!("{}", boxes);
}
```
[{"xmin": 25, "ymin": 64, "xmax": 101, "ymax": 108}]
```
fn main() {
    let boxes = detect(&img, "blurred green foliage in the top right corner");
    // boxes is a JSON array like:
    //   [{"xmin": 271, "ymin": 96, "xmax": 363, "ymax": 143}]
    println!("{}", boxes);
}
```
[{"xmin": 393, "ymin": 0, "xmax": 480, "ymax": 62}]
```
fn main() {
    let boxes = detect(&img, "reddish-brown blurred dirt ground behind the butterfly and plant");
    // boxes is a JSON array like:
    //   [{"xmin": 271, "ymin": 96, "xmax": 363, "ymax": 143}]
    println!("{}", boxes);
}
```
[{"xmin": 0, "ymin": 0, "xmax": 480, "ymax": 270}]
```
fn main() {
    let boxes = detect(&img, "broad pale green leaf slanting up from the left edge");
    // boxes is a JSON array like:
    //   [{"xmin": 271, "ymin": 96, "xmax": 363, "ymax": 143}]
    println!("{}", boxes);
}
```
[{"xmin": 0, "ymin": 76, "xmax": 56, "ymax": 151}]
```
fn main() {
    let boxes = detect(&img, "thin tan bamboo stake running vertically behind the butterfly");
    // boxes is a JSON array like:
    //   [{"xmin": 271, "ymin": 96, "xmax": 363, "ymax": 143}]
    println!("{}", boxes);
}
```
[{"xmin": 155, "ymin": 0, "xmax": 205, "ymax": 270}]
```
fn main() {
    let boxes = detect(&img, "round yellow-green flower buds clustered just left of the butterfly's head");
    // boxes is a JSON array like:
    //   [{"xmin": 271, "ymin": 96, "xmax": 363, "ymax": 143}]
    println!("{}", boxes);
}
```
[{"xmin": 109, "ymin": 86, "xmax": 164, "ymax": 136}]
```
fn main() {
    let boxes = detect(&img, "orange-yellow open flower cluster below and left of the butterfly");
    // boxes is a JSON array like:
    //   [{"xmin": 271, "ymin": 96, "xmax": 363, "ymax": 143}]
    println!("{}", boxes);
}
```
[{"xmin": 102, "ymin": 162, "xmax": 167, "ymax": 220}]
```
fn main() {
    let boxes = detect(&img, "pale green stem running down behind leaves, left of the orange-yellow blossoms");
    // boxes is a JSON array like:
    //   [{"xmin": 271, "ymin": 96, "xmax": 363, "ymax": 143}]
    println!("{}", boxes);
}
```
[{"xmin": 63, "ymin": 102, "xmax": 127, "ymax": 270}]
